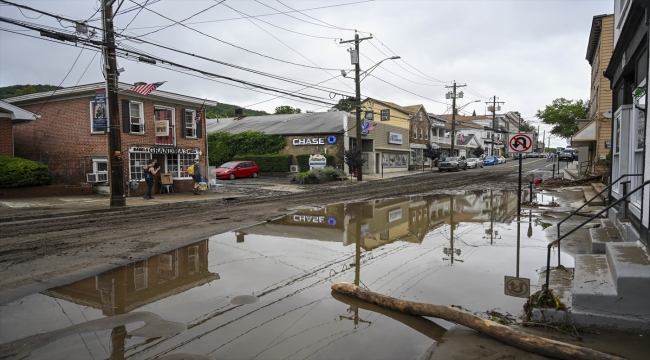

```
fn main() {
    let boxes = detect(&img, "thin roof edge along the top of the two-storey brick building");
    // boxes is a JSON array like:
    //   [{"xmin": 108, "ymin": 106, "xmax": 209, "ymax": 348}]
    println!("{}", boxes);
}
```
[{"xmin": 4, "ymin": 82, "xmax": 217, "ymax": 106}]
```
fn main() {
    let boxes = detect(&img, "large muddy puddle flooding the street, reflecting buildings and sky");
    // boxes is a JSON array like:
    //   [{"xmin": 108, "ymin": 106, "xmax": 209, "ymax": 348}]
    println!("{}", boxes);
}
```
[{"xmin": 0, "ymin": 191, "xmax": 573, "ymax": 359}]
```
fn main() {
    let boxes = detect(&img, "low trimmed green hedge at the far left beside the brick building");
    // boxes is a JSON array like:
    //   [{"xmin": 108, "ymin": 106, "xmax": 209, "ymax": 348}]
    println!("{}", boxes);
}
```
[{"xmin": 0, "ymin": 156, "xmax": 53, "ymax": 188}]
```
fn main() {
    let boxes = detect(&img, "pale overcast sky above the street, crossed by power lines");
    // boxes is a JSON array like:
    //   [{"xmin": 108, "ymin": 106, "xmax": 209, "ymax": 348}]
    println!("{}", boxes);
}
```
[{"xmin": 0, "ymin": 0, "xmax": 614, "ymax": 145}]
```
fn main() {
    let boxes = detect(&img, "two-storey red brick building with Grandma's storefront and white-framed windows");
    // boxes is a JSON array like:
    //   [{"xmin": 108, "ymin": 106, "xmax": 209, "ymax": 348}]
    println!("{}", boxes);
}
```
[{"xmin": 5, "ymin": 82, "xmax": 216, "ymax": 196}]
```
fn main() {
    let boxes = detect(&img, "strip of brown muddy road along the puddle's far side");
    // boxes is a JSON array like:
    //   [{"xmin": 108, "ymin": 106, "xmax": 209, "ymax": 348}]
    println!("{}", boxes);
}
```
[{"xmin": 0, "ymin": 168, "xmax": 517, "ymax": 291}]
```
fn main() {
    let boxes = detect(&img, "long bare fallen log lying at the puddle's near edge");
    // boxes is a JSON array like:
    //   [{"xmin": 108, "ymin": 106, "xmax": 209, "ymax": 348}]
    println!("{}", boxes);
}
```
[{"xmin": 332, "ymin": 282, "xmax": 622, "ymax": 360}]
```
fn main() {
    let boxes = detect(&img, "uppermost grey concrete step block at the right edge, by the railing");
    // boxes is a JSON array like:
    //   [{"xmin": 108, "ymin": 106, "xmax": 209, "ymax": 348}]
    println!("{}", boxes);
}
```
[{"xmin": 605, "ymin": 242, "xmax": 650, "ymax": 304}]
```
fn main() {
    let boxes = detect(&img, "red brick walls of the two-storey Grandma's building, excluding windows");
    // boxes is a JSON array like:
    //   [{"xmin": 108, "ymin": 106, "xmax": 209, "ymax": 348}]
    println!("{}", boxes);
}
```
[{"xmin": 14, "ymin": 95, "xmax": 206, "ymax": 192}]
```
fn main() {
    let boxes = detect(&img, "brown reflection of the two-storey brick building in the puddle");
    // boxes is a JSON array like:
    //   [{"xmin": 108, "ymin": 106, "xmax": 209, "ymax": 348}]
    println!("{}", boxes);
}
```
[{"xmin": 44, "ymin": 239, "xmax": 219, "ymax": 316}]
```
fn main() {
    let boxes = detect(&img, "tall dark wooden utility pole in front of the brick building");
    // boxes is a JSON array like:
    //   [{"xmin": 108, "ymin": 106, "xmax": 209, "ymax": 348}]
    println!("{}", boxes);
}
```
[{"xmin": 102, "ymin": 0, "xmax": 126, "ymax": 206}]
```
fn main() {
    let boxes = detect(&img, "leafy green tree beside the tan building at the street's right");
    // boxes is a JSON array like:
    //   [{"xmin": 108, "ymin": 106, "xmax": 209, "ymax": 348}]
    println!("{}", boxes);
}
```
[{"xmin": 535, "ymin": 98, "xmax": 589, "ymax": 139}]
